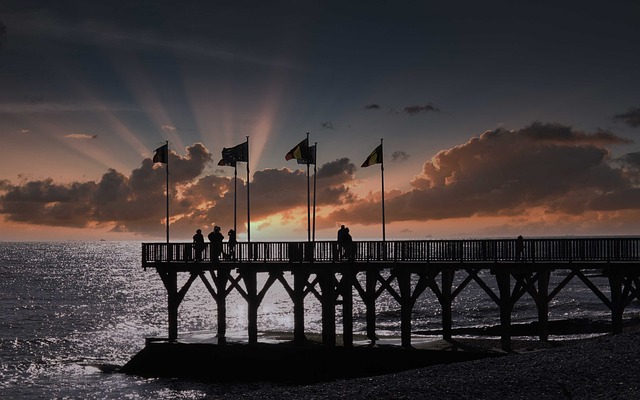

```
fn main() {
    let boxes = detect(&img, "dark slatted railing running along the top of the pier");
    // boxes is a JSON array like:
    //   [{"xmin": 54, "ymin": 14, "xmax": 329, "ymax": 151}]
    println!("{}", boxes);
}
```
[{"xmin": 142, "ymin": 238, "xmax": 640, "ymax": 266}]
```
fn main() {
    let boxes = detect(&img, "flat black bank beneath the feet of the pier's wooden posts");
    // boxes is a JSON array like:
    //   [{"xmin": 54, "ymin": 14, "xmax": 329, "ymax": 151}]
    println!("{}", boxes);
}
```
[{"xmin": 118, "ymin": 319, "xmax": 640, "ymax": 385}]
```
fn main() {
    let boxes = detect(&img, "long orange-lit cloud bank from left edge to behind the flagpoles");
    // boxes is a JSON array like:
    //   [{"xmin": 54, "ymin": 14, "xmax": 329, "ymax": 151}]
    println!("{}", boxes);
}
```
[{"xmin": 0, "ymin": 144, "xmax": 356, "ymax": 237}]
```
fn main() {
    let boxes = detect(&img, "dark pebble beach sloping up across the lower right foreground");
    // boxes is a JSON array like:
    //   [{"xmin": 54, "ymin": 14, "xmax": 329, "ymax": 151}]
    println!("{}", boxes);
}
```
[{"xmin": 216, "ymin": 327, "xmax": 640, "ymax": 400}]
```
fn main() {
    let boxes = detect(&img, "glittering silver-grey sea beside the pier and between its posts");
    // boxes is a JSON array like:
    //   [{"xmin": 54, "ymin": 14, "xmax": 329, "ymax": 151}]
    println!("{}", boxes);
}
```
[{"xmin": 0, "ymin": 242, "xmax": 640, "ymax": 399}]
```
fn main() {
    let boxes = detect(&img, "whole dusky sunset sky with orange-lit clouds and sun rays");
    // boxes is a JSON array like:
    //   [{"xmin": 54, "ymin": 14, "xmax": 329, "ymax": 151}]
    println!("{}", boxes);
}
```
[{"xmin": 0, "ymin": 0, "xmax": 640, "ymax": 241}]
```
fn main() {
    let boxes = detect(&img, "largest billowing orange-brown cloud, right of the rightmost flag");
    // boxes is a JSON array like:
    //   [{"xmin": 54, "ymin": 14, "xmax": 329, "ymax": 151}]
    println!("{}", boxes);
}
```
[{"xmin": 328, "ymin": 123, "xmax": 640, "ymax": 224}]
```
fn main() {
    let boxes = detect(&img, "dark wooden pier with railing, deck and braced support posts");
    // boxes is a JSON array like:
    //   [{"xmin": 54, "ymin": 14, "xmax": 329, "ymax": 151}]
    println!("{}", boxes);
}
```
[{"xmin": 142, "ymin": 237, "xmax": 640, "ymax": 349}]
